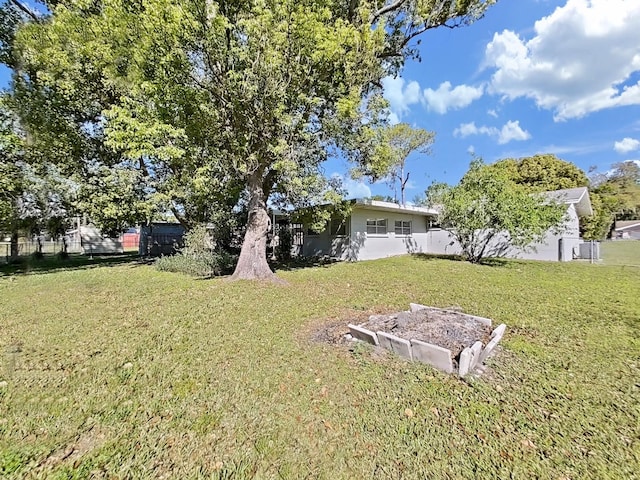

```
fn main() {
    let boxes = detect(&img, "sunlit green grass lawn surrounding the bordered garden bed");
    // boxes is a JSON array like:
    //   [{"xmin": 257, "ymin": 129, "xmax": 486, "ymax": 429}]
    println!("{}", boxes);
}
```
[{"xmin": 0, "ymin": 257, "xmax": 640, "ymax": 479}]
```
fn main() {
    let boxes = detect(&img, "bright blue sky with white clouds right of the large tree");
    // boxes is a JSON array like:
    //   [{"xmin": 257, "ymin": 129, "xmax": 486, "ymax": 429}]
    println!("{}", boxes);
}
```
[{"xmin": 336, "ymin": 0, "xmax": 640, "ymax": 199}]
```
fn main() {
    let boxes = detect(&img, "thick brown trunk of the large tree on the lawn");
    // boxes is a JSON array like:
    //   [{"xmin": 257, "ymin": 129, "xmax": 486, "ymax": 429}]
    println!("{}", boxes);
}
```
[{"xmin": 231, "ymin": 174, "xmax": 278, "ymax": 281}]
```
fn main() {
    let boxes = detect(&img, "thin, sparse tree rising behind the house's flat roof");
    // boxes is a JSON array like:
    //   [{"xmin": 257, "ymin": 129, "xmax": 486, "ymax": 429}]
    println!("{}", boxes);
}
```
[{"xmin": 351, "ymin": 123, "xmax": 435, "ymax": 205}]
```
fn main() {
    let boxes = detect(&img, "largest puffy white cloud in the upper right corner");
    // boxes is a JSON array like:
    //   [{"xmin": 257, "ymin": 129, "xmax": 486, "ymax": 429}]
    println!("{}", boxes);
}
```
[{"xmin": 485, "ymin": 0, "xmax": 640, "ymax": 121}]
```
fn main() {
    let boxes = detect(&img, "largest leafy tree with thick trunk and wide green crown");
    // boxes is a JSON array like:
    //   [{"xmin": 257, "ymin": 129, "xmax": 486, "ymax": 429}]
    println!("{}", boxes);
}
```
[{"xmin": 16, "ymin": 0, "xmax": 494, "ymax": 278}]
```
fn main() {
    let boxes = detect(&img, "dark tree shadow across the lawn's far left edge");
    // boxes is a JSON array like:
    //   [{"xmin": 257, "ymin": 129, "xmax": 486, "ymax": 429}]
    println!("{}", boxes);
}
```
[{"xmin": 0, "ymin": 252, "xmax": 149, "ymax": 277}]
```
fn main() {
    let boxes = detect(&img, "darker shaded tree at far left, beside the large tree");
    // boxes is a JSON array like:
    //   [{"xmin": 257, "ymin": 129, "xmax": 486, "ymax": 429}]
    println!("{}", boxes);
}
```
[{"xmin": 0, "ymin": 0, "xmax": 159, "ymax": 235}]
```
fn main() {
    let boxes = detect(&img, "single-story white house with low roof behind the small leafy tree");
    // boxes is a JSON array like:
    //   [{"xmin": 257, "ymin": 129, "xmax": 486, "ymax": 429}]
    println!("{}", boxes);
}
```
[{"xmin": 301, "ymin": 187, "xmax": 592, "ymax": 261}]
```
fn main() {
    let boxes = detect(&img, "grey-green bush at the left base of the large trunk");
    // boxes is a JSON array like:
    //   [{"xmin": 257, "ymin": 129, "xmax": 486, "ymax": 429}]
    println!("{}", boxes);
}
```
[{"xmin": 155, "ymin": 225, "xmax": 238, "ymax": 277}]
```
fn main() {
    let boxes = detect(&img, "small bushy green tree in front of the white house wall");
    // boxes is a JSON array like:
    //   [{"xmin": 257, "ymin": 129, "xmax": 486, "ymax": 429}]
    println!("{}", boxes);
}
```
[{"xmin": 426, "ymin": 159, "xmax": 565, "ymax": 263}]
